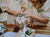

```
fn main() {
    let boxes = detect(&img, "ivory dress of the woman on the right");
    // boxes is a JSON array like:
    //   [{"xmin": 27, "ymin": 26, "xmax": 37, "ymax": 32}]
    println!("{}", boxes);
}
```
[{"xmin": 27, "ymin": 0, "xmax": 50, "ymax": 26}]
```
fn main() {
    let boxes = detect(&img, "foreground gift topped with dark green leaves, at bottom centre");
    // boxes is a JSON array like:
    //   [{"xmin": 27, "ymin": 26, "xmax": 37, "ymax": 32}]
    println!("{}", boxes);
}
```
[{"xmin": 15, "ymin": 28, "xmax": 35, "ymax": 37}]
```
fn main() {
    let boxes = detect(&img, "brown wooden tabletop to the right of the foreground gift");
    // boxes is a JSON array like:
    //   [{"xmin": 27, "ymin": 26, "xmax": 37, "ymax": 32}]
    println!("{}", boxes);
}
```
[{"xmin": 33, "ymin": 26, "xmax": 50, "ymax": 35}]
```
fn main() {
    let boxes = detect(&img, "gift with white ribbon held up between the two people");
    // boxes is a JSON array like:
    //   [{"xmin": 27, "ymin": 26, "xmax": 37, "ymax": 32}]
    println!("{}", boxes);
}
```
[{"xmin": 15, "ymin": 15, "xmax": 30, "ymax": 28}]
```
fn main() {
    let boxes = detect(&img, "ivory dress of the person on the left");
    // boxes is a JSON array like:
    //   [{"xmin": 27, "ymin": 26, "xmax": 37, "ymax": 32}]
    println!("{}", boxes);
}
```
[{"xmin": 1, "ymin": 0, "xmax": 27, "ymax": 24}]
